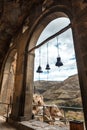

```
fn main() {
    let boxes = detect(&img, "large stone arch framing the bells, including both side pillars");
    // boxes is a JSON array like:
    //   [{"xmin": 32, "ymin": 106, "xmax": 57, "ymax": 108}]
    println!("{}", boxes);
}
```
[{"xmin": 8, "ymin": 1, "xmax": 87, "ymax": 129}]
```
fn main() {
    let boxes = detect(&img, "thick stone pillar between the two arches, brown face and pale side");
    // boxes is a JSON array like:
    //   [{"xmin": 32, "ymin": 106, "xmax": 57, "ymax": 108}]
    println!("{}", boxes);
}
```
[{"xmin": 9, "ymin": 31, "xmax": 34, "ymax": 121}]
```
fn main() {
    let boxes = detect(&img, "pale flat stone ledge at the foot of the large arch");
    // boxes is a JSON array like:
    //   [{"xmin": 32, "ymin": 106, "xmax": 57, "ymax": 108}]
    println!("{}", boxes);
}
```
[{"xmin": 9, "ymin": 120, "xmax": 69, "ymax": 130}]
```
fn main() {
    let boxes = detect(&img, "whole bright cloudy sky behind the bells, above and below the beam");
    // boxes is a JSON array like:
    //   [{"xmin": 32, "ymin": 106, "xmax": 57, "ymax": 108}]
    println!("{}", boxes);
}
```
[{"xmin": 34, "ymin": 18, "xmax": 78, "ymax": 81}]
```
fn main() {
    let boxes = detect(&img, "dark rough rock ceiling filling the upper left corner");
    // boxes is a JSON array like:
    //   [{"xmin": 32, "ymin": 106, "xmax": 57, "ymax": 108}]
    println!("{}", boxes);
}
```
[{"xmin": 0, "ymin": 0, "xmax": 87, "ymax": 70}]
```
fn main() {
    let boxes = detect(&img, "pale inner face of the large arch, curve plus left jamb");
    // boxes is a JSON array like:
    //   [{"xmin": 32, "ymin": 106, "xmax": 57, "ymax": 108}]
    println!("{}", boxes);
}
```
[{"xmin": 24, "ymin": 12, "xmax": 68, "ymax": 121}]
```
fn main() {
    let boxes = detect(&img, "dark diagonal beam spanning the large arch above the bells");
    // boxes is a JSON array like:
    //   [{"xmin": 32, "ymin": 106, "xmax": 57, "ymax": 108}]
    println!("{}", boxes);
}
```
[{"xmin": 28, "ymin": 23, "xmax": 71, "ymax": 53}]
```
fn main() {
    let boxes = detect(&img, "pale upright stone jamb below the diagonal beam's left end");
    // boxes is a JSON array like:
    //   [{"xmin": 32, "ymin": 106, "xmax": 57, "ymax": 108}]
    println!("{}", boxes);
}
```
[{"xmin": 24, "ymin": 53, "xmax": 34, "ymax": 119}]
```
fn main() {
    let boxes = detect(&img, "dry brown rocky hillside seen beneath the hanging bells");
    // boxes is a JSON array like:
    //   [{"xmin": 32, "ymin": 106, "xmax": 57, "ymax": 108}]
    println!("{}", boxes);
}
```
[{"xmin": 34, "ymin": 75, "xmax": 82, "ymax": 107}]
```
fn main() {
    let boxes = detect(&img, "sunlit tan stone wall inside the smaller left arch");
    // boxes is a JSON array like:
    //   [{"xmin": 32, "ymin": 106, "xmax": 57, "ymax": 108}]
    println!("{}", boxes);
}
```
[{"xmin": 0, "ymin": 49, "xmax": 17, "ymax": 116}]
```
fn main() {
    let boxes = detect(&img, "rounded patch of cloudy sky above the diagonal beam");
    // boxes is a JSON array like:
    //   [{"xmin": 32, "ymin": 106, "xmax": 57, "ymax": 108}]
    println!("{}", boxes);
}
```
[{"xmin": 37, "ymin": 18, "xmax": 70, "ymax": 44}]
